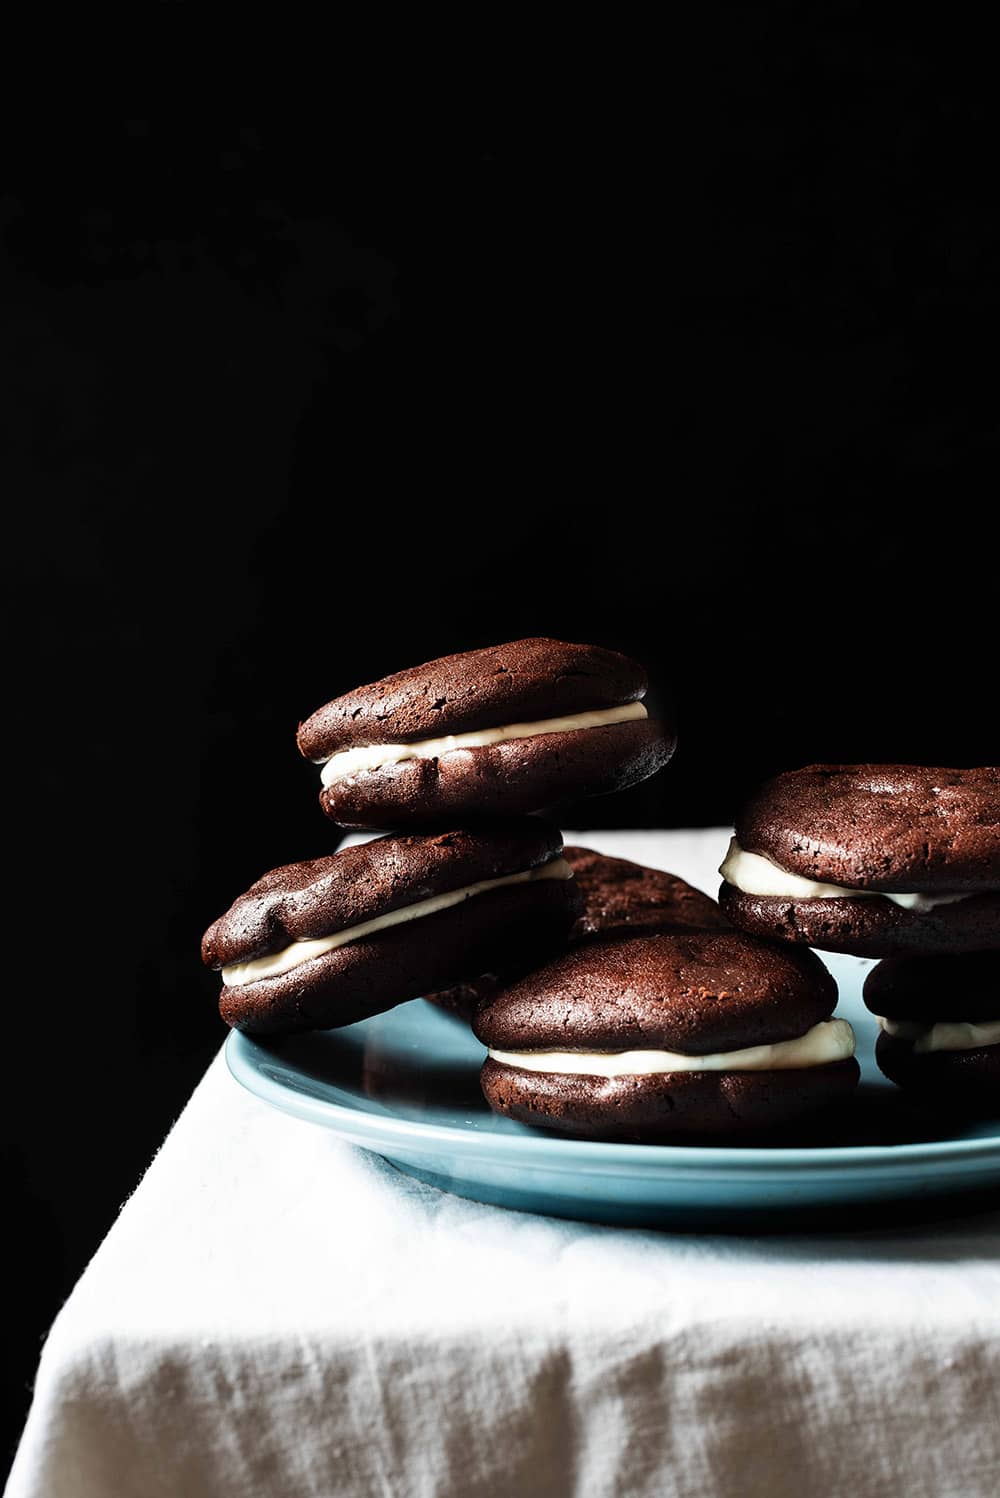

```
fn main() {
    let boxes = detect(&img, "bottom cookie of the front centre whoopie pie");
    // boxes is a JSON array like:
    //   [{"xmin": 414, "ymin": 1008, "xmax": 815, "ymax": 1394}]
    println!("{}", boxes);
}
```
[{"xmin": 479, "ymin": 1058, "xmax": 861, "ymax": 1143}]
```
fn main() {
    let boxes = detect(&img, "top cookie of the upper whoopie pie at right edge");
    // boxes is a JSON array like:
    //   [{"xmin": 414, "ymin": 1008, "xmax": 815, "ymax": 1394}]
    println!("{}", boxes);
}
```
[{"xmin": 737, "ymin": 764, "xmax": 1000, "ymax": 893}]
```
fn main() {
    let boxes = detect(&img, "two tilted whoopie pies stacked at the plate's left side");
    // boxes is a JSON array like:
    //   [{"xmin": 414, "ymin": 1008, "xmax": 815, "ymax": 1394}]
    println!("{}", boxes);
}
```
[{"xmin": 202, "ymin": 640, "xmax": 674, "ymax": 1035}]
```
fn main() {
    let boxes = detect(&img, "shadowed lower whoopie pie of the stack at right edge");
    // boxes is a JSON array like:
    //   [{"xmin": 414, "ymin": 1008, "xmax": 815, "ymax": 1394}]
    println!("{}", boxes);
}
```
[{"xmin": 864, "ymin": 951, "xmax": 1000, "ymax": 1116}]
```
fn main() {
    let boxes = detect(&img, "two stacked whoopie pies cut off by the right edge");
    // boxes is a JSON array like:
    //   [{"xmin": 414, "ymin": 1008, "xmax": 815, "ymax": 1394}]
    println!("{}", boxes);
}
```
[{"xmin": 720, "ymin": 764, "xmax": 1000, "ymax": 1109}]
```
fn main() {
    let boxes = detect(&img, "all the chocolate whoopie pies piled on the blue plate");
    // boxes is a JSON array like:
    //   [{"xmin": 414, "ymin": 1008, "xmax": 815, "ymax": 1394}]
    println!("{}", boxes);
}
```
[{"xmin": 202, "ymin": 640, "xmax": 1000, "ymax": 1140}]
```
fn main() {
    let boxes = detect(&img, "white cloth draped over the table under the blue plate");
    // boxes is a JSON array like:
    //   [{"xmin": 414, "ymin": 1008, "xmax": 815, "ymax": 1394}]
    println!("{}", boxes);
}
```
[{"xmin": 7, "ymin": 830, "xmax": 1000, "ymax": 1498}]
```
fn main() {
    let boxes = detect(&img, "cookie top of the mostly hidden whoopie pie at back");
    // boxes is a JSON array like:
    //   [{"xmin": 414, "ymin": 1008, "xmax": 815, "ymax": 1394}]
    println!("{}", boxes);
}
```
[{"xmin": 563, "ymin": 845, "xmax": 729, "ymax": 941}]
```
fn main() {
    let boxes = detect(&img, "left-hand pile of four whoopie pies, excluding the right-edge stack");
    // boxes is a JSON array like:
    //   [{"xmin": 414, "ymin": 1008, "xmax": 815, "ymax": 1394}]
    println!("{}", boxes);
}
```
[{"xmin": 202, "ymin": 640, "xmax": 874, "ymax": 1140}]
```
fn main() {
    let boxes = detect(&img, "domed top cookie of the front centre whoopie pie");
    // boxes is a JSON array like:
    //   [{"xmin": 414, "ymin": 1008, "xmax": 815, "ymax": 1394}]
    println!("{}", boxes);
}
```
[{"xmin": 473, "ymin": 930, "xmax": 837, "ymax": 1056}]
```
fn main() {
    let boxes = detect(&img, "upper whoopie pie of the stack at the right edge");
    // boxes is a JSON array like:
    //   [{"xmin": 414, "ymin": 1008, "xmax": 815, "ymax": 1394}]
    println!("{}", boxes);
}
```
[{"xmin": 719, "ymin": 764, "xmax": 1000, "ymax": 957}]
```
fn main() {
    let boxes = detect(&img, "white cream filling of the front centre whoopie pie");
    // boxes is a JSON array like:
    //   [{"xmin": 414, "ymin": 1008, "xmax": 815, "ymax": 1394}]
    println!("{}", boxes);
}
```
[{"xmin": 490, "ymin": 1020, "xmax": 855, "ymax": 1077}]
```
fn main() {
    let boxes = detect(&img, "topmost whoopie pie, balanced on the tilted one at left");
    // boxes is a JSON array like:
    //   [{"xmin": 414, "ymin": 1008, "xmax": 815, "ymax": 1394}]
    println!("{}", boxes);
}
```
[{"xmin": 298, "ymin": 640, "xmax": 675, "ymax": 827}]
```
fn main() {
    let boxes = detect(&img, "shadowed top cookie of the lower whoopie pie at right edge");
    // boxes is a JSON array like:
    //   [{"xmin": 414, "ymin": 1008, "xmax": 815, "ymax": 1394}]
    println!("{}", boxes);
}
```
[{"xmin": 864, "ymin": 951, "xmax": 1000, "ymax": 1023}]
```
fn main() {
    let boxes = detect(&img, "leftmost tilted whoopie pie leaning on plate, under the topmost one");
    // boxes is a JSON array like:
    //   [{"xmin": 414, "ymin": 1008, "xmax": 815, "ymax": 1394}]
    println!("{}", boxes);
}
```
[{"xmin": 202, "ymin": 816, "xmax": 578, "ymax": 1034}]
